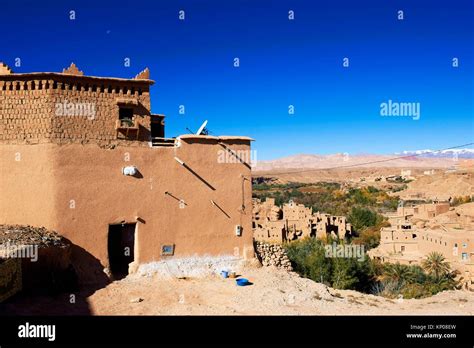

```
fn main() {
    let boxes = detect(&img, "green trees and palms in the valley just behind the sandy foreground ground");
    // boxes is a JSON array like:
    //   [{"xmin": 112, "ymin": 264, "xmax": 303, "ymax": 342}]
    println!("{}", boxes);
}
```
[{"xmin": 285, "ymin": 238, "xmax": 458, "ymax": 298}]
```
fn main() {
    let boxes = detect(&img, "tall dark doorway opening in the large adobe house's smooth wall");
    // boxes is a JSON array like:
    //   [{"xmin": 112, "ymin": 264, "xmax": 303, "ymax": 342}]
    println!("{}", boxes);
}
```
[{"xmin": 108, "ymin": 223, "xmax": 136, "ymax": 279}]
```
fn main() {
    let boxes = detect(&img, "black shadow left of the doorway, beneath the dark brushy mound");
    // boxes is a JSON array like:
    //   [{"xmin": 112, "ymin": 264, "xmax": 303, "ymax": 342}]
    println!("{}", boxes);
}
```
[{"xmin": 0, "ymin": 239, "xmax": 110, "ymax": 315}]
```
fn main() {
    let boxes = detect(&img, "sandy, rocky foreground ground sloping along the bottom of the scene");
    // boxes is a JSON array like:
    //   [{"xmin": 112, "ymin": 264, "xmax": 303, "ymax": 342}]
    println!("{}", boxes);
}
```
[{"xmin": 2, "ymin": 267, "xmax": 474, "ymax": 315}]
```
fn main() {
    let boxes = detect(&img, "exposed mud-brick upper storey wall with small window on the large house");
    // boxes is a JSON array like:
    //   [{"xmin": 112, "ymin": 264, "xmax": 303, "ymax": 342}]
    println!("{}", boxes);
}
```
[{"xmin": 0, "ymin": 77, "xmax": 150, "ymax": 147}]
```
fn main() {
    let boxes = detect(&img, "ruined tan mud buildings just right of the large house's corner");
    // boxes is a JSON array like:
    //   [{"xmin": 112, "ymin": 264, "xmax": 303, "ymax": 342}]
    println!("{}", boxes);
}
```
[{"xmin": 253, "ymin": 198, "xmax": 352, "ymax": 243}]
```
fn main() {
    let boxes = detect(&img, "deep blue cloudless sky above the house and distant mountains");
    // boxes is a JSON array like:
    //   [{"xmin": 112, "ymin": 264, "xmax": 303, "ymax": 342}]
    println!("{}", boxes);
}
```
[{"xmin": 0, "ymin": 0, "xmax": 474, "ymax": 160}]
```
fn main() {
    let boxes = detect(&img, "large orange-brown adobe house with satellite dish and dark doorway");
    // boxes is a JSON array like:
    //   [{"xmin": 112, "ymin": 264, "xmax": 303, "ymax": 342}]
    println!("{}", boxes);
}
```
[{"xmin": 0, "ymin": 64, "xmax": 254, "ymax": 279}]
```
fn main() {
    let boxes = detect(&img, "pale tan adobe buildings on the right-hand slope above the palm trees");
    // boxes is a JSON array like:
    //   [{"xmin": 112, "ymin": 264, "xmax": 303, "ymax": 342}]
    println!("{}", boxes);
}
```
[{"xmin": 369, "ymin": 203, "xmax": 474, "ymax": 288}]
